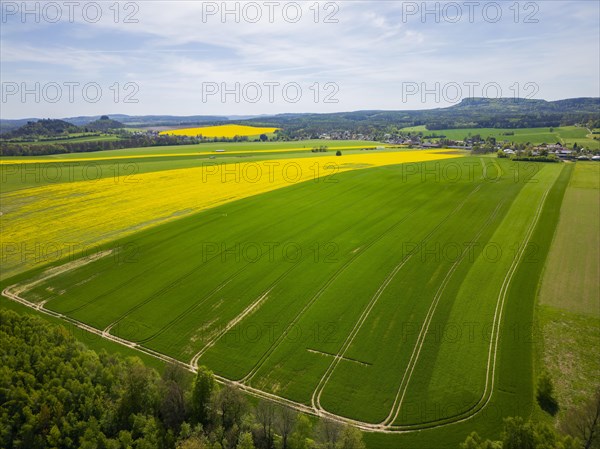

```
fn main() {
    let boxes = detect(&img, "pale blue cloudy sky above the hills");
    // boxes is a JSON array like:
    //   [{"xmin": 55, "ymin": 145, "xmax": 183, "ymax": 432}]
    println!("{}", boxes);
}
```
[{"xmin": 0, "ymin": 0, "xmax": 600, "ymax": 119}]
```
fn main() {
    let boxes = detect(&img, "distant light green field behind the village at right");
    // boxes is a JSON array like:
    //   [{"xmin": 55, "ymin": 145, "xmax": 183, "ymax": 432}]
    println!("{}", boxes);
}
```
[{"xmin": 403, "ymin": 126, "xmax": 600, "ymax": 150}]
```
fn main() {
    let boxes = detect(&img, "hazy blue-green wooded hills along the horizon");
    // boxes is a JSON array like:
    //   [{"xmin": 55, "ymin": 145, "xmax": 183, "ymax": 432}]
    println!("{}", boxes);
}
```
[{"xmin": 0, "ymin": 98, "xmax": 600, "ymax": 137}]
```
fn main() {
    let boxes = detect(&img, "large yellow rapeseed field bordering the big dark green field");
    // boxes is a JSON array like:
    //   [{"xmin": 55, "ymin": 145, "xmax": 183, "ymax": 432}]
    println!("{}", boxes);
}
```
[{"xmin": 0, "ymin": 150, "xmax": 459, "ymax": 279}]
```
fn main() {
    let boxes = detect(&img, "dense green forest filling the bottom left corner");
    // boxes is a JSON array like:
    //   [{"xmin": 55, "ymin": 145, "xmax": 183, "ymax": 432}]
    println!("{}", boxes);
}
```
[{"xmin": 0, "ymin": 310, "xmax": 364, "ymax": 449}]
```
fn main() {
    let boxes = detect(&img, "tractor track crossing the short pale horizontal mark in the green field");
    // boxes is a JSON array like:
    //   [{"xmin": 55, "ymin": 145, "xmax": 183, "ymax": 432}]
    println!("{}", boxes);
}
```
[{"xmin": 311, "ymin": 184, "xmax": 481, "ymax": 411}]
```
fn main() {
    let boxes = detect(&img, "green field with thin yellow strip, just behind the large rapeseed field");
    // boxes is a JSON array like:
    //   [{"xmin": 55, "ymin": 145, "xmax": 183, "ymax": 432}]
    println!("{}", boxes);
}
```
[{"xmin": 0, "ymin": 140, "xmax": 381, "ymax": 193}]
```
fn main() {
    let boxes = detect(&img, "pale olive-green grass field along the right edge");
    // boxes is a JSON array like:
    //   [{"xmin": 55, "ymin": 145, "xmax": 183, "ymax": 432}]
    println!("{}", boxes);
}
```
[{"xmin": 537, "ymin": 162, "xmax": 600, "ymax": 421}]
